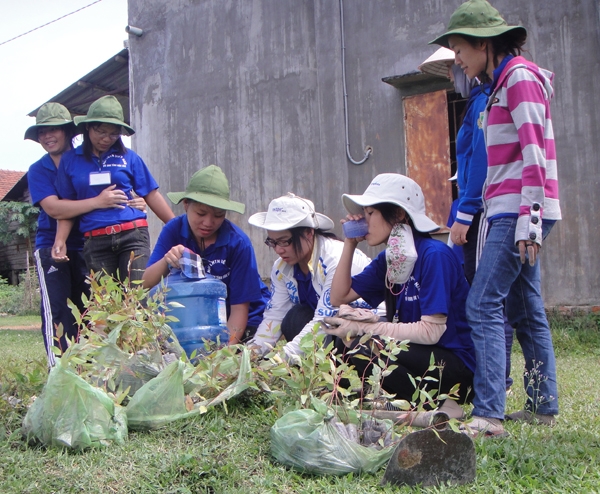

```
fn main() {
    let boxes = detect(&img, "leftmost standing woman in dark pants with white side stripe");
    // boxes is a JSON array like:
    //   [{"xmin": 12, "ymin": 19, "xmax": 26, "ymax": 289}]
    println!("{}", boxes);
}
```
[{"xmin": 25, "ymin": 103, "xmax": 145, "ymax": 367}]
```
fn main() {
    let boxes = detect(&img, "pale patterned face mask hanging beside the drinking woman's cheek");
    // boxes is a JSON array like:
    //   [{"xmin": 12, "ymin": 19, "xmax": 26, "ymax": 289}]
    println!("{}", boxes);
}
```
[{"xmin": 385, "ymin": 223, "xmax": 418, "ymax": 290}]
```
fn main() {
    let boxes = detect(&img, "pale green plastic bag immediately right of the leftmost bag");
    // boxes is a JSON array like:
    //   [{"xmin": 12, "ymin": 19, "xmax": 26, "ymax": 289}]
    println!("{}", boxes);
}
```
[{"xmin": 125, "ymin": 360, "xmax": 199, "ymax": 429}]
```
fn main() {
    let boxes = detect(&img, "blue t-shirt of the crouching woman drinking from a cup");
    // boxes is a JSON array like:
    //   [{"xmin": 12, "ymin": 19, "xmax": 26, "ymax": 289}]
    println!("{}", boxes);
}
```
[{"xmin": 352, "ymin": 235, "xmax": 475, "ymax": 372}]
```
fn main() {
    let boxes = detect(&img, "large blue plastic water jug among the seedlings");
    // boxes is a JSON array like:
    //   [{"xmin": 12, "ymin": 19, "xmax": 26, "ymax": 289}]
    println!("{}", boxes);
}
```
[{"xmin": 158, "ymin": 273, "xmax": 229, "ymax": 357}]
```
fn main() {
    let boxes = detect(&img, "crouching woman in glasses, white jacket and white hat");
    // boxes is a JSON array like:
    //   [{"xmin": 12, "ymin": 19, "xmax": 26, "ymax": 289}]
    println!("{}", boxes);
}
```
[{"xmin": 248, "ymin": 193, "xmax": 370, "ymax": 356}]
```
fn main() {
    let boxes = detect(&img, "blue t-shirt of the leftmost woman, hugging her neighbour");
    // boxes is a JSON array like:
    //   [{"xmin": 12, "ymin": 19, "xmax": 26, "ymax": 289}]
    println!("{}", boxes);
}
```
[{"xmin": 27, "ymin": 154, "xmax": 83, "ymax": 250}]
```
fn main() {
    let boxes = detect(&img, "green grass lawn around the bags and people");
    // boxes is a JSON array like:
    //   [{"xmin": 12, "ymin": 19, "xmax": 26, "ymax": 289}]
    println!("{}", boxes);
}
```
[{"xmin": 0, "ymin": 316, "xmax": 600, "ymax": 494}]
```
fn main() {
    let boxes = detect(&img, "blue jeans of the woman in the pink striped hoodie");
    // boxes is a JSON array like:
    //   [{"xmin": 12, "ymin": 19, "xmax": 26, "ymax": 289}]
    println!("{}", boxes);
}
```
[{"xmin": 467, "ymin": 218, "xmax": 558, "ymax": 419}]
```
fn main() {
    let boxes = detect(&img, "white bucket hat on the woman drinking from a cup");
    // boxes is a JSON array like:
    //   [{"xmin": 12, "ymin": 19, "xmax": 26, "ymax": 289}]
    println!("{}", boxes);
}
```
[{"xmin": 342, "ymin": 173, "xmax": 440, "ymax": 233}]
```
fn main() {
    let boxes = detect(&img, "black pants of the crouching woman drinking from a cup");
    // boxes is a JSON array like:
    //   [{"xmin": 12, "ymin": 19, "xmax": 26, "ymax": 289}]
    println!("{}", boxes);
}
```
[{"xmin": 336, "ymin": 337, "xmax": 473, "ymax": 404}]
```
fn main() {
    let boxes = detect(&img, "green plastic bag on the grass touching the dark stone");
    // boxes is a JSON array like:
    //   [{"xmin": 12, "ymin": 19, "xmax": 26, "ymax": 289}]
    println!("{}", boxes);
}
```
[{"xmin": 271, "ymin": 409, "xmax": 395, "ymax": 475}]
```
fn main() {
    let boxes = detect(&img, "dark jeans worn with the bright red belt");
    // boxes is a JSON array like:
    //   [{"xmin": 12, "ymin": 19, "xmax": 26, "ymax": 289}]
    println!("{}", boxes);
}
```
[{"xmin": 83, "ymin": 226, "xmax": 150, "ymax": 281}]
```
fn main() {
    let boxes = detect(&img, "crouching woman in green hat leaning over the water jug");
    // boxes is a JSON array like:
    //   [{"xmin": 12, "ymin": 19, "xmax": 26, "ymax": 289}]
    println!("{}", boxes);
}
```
[{"xmin": 142, "ymin": 165, "xmax": 269, "ymax": 344}]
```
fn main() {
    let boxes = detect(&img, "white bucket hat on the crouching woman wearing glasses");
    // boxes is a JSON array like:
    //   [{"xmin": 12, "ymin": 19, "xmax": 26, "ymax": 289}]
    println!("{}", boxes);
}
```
[{"xmin": 248, "ymin": 192, "xmax": 334, "ymax": 232}]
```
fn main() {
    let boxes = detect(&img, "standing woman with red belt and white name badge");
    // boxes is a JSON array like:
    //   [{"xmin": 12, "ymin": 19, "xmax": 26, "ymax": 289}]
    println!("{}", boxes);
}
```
[{"xmin": 52, "ymin": 96, "xmax": 174, "ymax": 281}]
